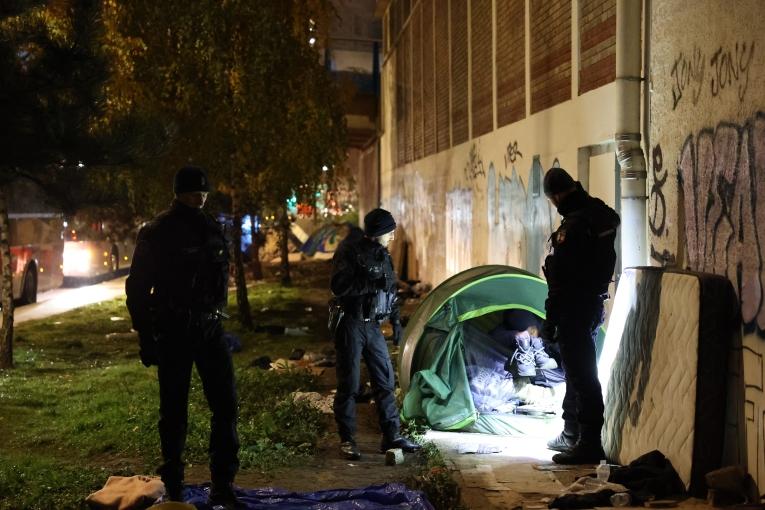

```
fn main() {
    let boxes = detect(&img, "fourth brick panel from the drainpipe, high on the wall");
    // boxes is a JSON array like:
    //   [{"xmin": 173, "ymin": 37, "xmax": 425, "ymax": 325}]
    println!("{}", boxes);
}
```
[{"xmin": 470, "ymin": 0, "xmax": 492, "ymax": 137}]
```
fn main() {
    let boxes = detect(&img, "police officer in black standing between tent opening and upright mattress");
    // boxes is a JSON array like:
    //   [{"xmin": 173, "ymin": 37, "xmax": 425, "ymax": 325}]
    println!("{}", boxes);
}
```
[{"xmin": 542, "ymin": 168, "xmax": 619, "ymax": 464}]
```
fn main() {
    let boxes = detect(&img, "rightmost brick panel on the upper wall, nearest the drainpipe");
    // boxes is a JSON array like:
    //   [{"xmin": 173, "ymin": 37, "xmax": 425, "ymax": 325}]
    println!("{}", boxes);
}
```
[{"xmin": 579, "ymin": 0, "xmax": 616, "ymax": 94}]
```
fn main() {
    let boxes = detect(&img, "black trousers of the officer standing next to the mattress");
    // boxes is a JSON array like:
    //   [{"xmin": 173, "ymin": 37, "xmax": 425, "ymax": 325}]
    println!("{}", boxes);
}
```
[{"xmin": 558, "ymin": 297, "xmax": 605, "ymax": 444}]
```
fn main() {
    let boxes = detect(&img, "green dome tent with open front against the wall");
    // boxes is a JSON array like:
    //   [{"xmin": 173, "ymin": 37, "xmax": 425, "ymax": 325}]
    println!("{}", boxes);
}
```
[{"xmin": 398, "ymin": 265, "xmax": 605, "ymax": 435}]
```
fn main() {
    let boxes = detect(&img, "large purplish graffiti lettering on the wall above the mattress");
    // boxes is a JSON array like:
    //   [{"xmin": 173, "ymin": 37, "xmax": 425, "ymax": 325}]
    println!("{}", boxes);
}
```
[{"xmin": 678, "ymin": 112, "xmax": 765, "ymax": 337}]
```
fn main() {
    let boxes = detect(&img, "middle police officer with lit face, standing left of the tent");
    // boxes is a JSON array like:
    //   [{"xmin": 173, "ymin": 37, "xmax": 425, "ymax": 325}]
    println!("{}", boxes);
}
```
[{"xmin": 330, "ymin": 209, "xmax": 420, "ymax": 460}]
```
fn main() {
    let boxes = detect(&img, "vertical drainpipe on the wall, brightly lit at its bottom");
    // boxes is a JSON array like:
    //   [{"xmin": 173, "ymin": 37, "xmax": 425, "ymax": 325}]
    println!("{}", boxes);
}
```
[{"xmin": 614, "ymin": 0, "xmax": 648, "ymax": 267}]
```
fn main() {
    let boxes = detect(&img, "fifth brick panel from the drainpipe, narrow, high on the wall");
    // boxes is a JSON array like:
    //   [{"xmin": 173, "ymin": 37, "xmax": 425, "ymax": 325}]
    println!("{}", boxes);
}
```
[{"xmin": 451, "ymin": 0, "xmax": 469, "ymax": 145}]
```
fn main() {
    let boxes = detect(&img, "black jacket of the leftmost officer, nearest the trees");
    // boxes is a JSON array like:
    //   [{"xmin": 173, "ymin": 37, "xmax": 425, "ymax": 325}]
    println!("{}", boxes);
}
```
[{"xmin": 125, "ymin": 201, "xmax": 229, "ymax": 331}]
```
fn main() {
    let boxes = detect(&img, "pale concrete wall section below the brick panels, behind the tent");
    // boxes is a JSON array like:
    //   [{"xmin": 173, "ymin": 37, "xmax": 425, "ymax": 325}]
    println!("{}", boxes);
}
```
[{"xmin": 381, "ymin": 80, "xmax": 617, "ymax": 284}]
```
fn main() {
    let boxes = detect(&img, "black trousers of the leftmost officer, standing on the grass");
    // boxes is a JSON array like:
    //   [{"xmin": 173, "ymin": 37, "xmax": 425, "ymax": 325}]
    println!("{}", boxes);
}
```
[{"xmin": 157, "ymin": 320, "xmax": 239, "ymax": 486}]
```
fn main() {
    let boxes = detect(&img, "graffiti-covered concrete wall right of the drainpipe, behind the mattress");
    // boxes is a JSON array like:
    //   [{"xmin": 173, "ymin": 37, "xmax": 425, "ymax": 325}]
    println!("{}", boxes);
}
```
[{"xmin": 648, "ymin": 0, "xmax": 765, "ymax": 488}]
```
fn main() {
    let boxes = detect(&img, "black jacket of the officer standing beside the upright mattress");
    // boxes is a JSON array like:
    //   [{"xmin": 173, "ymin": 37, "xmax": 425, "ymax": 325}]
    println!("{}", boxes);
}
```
[{"xmin": 544, "ymin": 183, "xmax": 620, "ymax": 320}]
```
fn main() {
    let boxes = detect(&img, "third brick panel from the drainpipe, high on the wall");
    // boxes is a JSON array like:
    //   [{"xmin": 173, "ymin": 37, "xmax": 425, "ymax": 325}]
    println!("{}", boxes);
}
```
[{"xmin": 495, "ymin": 0, "xmax": 526, "ymax": 127}]
